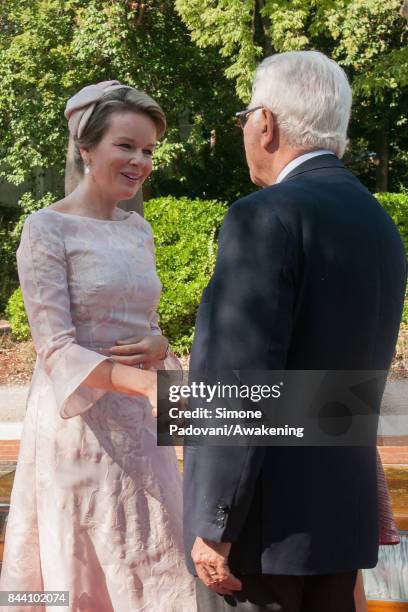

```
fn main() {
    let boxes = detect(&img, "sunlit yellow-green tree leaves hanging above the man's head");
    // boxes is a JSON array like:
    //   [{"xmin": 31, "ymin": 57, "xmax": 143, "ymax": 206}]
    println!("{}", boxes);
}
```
[{"xmin": 176, "ymin": 0, "xmax": 408, "ymax": 101}]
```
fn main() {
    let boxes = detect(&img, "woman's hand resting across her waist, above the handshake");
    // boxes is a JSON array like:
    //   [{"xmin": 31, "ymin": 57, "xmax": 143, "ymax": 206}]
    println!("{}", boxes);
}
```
[{"xmin": 109, "ymin": 336, "xmax": 169, "ymax": 370}]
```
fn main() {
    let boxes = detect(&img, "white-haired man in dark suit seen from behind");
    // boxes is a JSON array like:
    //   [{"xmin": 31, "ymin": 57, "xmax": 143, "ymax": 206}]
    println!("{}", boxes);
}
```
[{"xmin": 184, "ymin": 51, "xmax": 406, "ymax": 612}]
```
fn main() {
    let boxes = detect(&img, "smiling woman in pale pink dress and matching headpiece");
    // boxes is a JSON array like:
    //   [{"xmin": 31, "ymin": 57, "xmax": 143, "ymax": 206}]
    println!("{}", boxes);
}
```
[{"xmin": 0, "ymin": 81, "xmax": 195, "ymax": 612}]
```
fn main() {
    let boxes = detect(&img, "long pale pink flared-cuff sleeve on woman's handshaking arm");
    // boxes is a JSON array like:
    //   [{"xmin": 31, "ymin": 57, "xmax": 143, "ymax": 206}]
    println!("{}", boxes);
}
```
[{"xmin": 17, "ymin": 214, "xmax": 109, "ymax": 418}]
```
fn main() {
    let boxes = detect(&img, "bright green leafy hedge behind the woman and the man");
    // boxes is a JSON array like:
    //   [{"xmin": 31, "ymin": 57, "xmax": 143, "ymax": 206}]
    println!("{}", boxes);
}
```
[{"xmin": 0, "ymin": 193, "xmax": 408, "ymax": 354}]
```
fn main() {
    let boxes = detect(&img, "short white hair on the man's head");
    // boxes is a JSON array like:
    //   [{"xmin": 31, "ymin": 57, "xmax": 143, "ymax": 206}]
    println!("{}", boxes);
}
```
[{"xmin": 251, "ymin": 51, "xmax": 352, "ymax": 157}]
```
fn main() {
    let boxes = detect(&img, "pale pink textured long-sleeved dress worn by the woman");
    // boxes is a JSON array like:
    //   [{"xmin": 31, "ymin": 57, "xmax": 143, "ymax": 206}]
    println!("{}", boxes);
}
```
[{"xmin": 0, "ymin": 209, "xmax": 196, "ymax": 612}]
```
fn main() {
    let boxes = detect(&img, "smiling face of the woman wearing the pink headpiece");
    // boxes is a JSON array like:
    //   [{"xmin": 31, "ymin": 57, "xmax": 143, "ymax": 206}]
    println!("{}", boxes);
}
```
[{"xmin": 81, "ymin": 111, "xmax": 157, "ymax": 202}]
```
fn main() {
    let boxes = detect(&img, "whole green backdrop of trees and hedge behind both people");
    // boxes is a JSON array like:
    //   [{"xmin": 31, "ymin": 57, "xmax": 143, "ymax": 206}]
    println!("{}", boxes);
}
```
[{"xmin": 0, "ymin": 0, "xmax": 408, "ymax": 353}]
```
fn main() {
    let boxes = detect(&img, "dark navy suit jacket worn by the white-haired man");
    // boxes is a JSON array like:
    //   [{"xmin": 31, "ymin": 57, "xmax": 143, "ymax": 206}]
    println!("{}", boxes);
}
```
[{"xmin": 184, "ymin": 155, "xmax": 406, "ymax": 575}]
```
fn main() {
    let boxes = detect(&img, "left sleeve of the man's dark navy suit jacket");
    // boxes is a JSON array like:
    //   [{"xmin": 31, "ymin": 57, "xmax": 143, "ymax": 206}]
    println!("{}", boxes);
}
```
[{"xmin": 189, "ymin": 200, "xmax": 295, "ymax": 542}]
